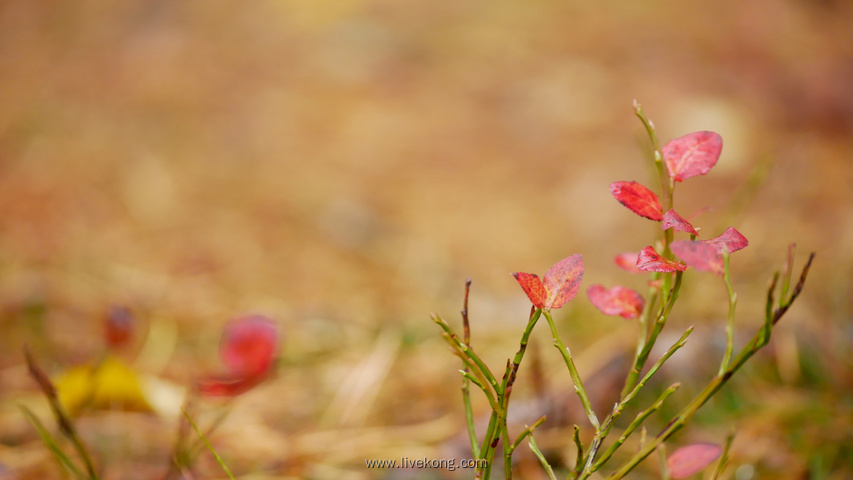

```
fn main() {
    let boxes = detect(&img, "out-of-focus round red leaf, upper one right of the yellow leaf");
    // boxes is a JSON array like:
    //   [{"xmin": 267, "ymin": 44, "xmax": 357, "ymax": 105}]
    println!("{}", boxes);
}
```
[{"xmin": 219, "ymin": 315, "xmax": 278, "ymax": 377}]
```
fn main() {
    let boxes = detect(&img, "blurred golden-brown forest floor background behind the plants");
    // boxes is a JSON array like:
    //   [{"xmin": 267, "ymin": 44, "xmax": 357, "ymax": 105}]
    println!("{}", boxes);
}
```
[{"xmin": 0, "ymin": 0, "xmax": 853, "ymax": 480}]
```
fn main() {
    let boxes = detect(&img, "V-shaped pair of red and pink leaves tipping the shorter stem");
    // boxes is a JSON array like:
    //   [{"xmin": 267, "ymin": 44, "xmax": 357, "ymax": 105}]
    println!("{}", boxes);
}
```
[{"xmin": 513, "ymin": 254, "xmax": 583, "ymax": 310}]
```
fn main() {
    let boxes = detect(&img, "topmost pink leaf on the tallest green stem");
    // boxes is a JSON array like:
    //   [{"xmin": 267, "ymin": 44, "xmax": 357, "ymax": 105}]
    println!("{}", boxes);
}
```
[{"xmin": 661, "ymin": 131, "xmax": 723, "ymax": 182}]
